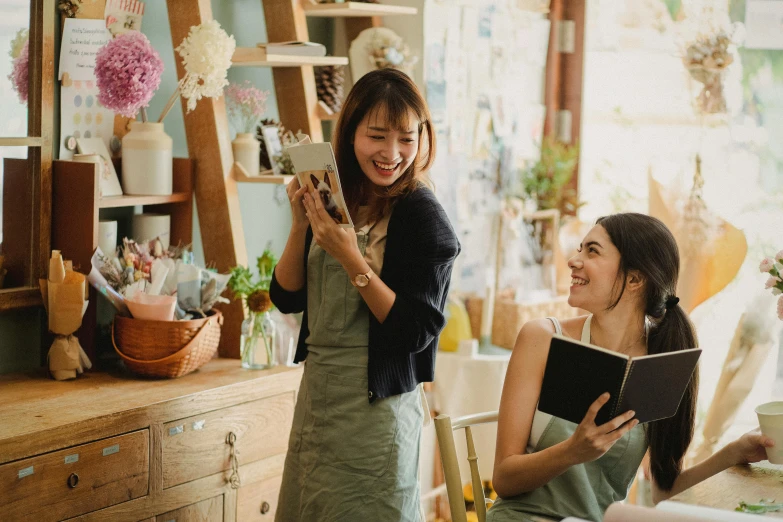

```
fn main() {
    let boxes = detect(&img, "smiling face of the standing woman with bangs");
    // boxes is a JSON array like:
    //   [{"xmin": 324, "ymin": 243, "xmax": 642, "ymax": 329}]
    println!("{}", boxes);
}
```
[{"xmin": 353, "ymin": 107, "xmax": 420, "ymax": 187}]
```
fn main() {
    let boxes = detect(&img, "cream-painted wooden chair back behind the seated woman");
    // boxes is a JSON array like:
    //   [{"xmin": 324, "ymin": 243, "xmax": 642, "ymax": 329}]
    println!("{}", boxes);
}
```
[{"xmin": 435, "ymin": 411, "xmax": 498, "ymax": 522}]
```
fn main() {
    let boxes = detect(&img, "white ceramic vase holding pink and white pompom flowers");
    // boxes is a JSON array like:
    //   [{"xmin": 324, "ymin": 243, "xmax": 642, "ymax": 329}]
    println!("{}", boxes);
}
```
[{"xmin": 122, "ymin": 121, "xmax": 173, "ymax": 196}]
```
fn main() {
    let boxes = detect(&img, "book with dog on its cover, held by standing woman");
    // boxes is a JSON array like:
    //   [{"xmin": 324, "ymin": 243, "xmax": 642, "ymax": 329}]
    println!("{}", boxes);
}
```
[{"xmin": 286, "ymin": 138, "xmax": 353, "ymax": 228}]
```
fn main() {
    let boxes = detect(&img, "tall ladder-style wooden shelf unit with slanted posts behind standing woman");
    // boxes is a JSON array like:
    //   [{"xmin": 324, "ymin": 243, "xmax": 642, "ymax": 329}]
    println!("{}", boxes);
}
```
[{"xmin": 166, "ymin": 0, "xmax": 416, "ymax": 358}]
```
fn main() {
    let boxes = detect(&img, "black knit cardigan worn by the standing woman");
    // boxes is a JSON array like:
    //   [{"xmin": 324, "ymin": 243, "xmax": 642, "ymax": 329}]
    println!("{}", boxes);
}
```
[{"xmin": 269, "ymin": 186, "xmax": 460, "ymax": 402}]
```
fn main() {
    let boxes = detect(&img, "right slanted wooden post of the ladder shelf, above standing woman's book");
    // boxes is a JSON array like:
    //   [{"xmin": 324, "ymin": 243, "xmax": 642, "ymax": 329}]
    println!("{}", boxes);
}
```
[{"xmin": 262, "ymin": 0, "xmax": 323, "ymax": 142}]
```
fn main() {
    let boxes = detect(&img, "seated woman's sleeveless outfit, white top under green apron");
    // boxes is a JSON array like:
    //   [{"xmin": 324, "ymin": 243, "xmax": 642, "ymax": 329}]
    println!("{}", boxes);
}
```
[{"xmin": 487, "ymin": 315, "xmax": 647, "ymax": 522}]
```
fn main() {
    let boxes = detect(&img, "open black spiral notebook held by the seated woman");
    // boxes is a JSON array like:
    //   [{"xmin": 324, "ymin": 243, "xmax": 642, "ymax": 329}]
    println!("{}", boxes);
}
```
[{"xmin": 538, "ymin": 335, "xmax": 701, "ymax": 425}]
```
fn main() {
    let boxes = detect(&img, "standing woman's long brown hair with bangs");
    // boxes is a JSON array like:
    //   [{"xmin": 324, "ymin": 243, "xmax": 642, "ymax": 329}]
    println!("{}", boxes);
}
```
[{"xmin": 332, "ymin": 68, "xmax": 435, "ymax": 217}]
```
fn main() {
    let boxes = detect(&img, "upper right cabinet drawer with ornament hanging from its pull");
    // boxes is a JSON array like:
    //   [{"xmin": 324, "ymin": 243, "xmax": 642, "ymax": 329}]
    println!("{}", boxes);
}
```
[{"xmin": 163, "ymin": 392, "xmax": 294, "ymax": 489}]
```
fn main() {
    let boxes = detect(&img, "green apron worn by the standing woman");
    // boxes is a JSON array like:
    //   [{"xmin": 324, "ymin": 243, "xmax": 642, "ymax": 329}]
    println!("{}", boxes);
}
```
[{"xmin": 275, "ymin": 221, "xmax": 424, "ymax": 522}]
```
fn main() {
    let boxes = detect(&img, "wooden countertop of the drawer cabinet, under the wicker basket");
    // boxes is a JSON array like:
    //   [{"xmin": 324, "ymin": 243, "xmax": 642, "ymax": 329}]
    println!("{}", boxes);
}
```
[{"xmin": 0, "ymin": 359, "xmax": 302, "ymax": 464}]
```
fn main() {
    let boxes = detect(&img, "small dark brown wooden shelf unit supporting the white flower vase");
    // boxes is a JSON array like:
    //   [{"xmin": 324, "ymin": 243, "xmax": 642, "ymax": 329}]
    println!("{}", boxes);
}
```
[{"xmin": 52, "ymin": 158, "xmax": 194, "ymax": 363}]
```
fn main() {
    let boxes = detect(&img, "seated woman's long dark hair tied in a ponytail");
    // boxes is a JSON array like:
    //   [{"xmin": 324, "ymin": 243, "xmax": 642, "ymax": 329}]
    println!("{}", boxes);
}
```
[{"xmin": 597, "ymin": 213, "xmax": 699, "ymax": 491}]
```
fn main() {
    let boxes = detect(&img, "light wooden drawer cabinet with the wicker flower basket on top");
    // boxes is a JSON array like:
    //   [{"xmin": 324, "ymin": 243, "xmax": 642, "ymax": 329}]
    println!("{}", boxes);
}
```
[{"xmin": 0, "ymin": 359, "xmax": 301, "ymax": 522}]
